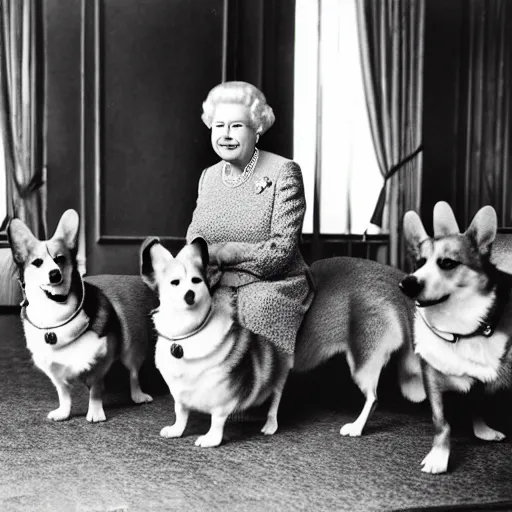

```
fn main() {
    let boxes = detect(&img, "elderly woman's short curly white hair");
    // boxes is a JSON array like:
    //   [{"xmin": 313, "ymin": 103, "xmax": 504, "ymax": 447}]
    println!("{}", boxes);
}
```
[{"xmin": 201, "ymin": 82, "xmax": 276, "ymax": 135}]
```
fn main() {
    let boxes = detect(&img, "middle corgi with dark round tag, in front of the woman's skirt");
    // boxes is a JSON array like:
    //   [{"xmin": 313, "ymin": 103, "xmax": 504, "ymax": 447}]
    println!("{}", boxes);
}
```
[{"xmin": 141, "ymin": 238, "xmax": 292, "ymax": 447}]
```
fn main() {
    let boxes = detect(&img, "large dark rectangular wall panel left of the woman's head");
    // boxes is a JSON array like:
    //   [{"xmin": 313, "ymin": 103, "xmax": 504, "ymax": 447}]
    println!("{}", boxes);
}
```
[{"xmin": 97, "ymin": 0, "xmax": 223, "ymax": 241}]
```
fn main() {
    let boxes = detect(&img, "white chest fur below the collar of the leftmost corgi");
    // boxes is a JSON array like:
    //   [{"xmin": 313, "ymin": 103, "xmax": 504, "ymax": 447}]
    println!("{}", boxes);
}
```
[{"xmin": 23, "ymin": 321, "xmax": 108, "ymax": 380}]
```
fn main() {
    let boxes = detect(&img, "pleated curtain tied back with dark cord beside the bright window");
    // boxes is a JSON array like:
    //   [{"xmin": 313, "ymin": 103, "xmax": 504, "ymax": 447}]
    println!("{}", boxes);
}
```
[{"xmin": 357, "ymin": 0, "xmax": 425, "ymax": 270}]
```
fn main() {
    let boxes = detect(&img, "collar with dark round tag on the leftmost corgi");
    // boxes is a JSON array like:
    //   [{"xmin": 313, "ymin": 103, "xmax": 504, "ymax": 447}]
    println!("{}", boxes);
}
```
[{"xmin": 21, "ymin": 277, "xmax": 90, "ymax": 347}]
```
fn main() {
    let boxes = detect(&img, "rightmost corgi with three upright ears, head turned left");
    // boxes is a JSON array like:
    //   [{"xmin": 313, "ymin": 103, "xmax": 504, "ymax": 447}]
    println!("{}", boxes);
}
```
[{"xmin": 400, "ymin": 202, "xmax": 512, "ymax": 473}]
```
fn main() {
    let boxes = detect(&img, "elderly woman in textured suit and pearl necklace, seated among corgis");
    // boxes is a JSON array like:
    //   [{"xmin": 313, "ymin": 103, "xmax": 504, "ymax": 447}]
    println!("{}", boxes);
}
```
[{"xmin": 187, "ymin": 82, "xmax": 313, "ymax": 354}]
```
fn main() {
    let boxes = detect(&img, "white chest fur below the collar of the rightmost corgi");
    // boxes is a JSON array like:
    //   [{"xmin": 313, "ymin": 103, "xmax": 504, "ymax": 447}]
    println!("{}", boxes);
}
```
[{"xmin": 414, "ymin": 313, "xmax": 509, "ymax": 391}]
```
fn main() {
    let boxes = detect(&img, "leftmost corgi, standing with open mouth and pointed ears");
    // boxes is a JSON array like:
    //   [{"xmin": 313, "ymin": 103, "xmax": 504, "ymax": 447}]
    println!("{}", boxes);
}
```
[{"xmin": 7, "ymin": 210, "xmax": 152, "ymax": 422}]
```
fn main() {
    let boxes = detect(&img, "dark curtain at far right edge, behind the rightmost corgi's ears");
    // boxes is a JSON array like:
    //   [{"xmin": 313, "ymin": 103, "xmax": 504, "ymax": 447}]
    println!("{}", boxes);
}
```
[{"xmin": 456, "ymin": 0, "xmax": 512, "ymax": 227}]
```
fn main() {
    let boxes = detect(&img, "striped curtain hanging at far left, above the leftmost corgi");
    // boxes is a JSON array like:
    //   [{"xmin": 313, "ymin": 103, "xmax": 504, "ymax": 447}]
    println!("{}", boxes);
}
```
[{"xmin": 0, "ymin": 0, "xmax": 46, "ymax": 237}]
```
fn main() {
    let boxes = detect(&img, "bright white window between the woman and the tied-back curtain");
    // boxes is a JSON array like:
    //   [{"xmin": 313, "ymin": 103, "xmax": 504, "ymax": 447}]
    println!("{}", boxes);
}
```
[{"xmin": 294, "ymin": 0, "xmax": 383, "ymax": 234}]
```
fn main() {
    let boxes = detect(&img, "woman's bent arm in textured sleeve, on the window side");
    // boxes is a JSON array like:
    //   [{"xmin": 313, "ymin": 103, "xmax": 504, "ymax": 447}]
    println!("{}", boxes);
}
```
[{"xmin": 210, "ymin": 162, "xmax": 306, "ymax": 279}]
